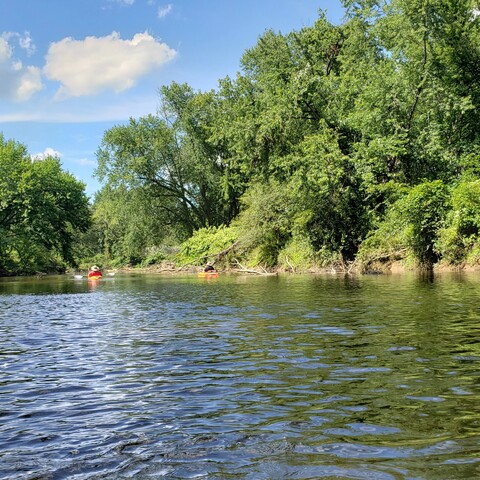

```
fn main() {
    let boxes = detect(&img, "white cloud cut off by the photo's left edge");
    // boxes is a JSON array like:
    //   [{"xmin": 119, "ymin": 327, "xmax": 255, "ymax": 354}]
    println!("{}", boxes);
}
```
[{"xmin": 0, "ymin": 34, "xmax": 43, "ymax": 102}]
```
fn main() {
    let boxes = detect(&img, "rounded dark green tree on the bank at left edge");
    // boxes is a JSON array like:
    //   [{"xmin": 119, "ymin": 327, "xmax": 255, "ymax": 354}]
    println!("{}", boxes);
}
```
[{"xmin": 0, "ymin": 135, "xmax": 91, "ymax": 273}]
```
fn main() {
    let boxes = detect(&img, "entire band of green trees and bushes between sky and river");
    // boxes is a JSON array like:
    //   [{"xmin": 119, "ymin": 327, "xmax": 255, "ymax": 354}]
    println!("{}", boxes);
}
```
[{"xmin": 0, "ymin": 0, "xmax": 480, "ymax": 275}]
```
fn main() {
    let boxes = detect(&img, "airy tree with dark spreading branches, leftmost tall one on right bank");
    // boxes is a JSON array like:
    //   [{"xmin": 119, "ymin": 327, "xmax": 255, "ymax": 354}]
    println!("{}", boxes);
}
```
[{"xmin": 96, "ymin": 84, "xmax": 234, "ymax": 237}]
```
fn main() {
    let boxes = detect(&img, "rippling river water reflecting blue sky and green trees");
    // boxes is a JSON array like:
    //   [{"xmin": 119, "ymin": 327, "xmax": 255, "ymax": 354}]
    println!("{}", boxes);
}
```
[{"xmin": 0, "ymin": 273, "xmax": 480, "ymax": 480}]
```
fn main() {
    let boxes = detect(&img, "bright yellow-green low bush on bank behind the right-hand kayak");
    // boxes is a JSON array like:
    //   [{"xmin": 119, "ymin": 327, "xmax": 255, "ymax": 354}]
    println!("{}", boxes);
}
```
[{"xmin": 175, "ymin": 225, "xmax": 238, "ymax": 265}]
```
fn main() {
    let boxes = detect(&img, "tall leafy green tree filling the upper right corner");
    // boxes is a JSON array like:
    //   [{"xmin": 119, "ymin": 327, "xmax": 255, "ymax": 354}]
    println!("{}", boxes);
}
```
[{"xmin": 340, "ymin": 0, "xmax": 480, "ymax": 184}]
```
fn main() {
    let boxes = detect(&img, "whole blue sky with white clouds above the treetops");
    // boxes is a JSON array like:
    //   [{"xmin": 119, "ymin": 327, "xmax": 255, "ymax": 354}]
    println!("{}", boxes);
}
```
[{"xmin": 0, "ymin": 0, "xmax": 343, "ymax": 196}]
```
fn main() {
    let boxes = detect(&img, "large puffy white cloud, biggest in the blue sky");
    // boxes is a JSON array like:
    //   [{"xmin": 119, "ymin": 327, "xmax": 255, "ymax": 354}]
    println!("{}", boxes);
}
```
[{"xmin": 43, "ymin": 32, "xmax": 177, "ymax": 98}]
